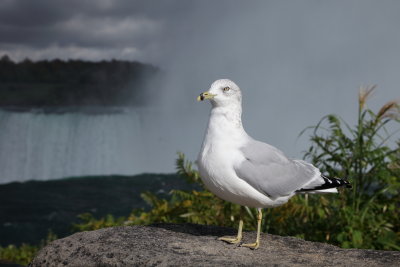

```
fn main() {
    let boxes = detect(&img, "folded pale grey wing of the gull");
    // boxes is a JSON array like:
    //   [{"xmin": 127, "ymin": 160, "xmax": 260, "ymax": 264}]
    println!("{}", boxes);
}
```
[{"xmin": 235, "ymin": 140, "xmax": 319, "ymax": 199}]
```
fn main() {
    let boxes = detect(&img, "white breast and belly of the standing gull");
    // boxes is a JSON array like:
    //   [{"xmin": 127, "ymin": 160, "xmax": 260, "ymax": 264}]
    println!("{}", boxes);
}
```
[{"xmin": 197, "ymin": 108, "xmax": 288, "ymax": 208}]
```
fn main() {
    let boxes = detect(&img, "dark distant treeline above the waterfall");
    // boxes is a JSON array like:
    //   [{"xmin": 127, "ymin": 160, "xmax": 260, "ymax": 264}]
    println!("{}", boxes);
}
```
[{"xmin": 0, "ymin": 55, "xmax": 159, "ymax": 108}]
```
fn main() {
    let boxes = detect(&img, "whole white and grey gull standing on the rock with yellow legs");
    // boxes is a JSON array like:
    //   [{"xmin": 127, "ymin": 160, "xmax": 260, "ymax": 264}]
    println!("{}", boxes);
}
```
[{"xmin": 197, "ymin": 79, "xmax": 351, "ymax": 249}]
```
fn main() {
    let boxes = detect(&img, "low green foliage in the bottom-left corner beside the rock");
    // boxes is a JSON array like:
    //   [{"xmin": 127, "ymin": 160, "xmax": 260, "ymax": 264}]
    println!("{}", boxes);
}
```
[{"xmin": 0, "ymin": 232, "xmax": 57, "ymax": 265}]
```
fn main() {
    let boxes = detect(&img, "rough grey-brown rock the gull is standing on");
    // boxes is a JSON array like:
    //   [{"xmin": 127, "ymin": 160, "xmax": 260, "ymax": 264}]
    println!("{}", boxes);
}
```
[{"xmin": 30, "ymin": 224, "xmax": 400, "ymax": 266}]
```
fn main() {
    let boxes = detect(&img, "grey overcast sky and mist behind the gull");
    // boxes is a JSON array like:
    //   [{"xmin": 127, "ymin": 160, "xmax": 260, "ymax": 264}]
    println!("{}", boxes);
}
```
[{"xmin": 0, "ymin": 0, "xmax": 400, "ymax": 171}]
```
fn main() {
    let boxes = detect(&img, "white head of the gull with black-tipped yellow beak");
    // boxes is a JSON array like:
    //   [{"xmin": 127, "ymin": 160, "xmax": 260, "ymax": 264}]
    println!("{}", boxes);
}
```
[{"xmin": 197, "ymin": 79, "xmax": 242, "ymax": 107}]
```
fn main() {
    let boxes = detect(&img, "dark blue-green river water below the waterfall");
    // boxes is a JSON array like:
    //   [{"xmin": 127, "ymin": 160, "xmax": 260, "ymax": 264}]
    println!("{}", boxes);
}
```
[{"xmin": 0, "ymin": 174, "xmax": 193, "ymax": 247}]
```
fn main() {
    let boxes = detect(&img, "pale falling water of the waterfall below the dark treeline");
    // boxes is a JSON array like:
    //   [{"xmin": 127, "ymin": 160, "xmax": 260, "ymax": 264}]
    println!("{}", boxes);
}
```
[{"xmin": 0, "ymin": 108, "xmax": 176, "ymax": 183}]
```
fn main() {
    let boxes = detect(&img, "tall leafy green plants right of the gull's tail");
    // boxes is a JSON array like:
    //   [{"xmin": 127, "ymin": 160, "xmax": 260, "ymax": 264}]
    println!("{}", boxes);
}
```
[{"xmin": 289, "ymin": 87, "xmax": 400, "ymax": 250}]
